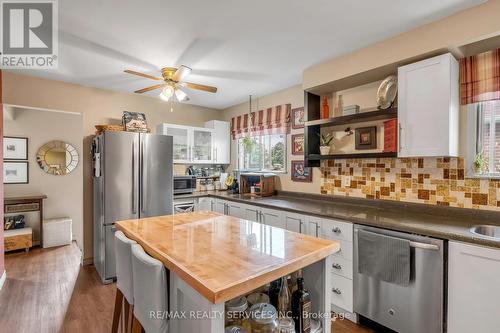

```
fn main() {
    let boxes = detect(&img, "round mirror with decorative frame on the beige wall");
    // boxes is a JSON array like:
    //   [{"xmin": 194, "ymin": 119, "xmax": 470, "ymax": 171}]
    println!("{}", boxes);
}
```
[{"xmin": 36, "ymin": 141, "xmax": 78, "ymax": 176}]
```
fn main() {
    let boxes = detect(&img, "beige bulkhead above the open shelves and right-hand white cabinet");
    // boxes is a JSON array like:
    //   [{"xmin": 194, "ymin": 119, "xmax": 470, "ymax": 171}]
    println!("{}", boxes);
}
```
[{"xmin": 303, "ymin": 0, "xmax": 500, "ymax": 89}]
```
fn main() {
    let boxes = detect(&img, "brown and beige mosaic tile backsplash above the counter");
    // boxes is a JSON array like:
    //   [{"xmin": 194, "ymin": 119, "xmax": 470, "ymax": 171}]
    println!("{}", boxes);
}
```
[{"xmin": 321, "ymin": 157, "xmax": 500, "ymax": 210}]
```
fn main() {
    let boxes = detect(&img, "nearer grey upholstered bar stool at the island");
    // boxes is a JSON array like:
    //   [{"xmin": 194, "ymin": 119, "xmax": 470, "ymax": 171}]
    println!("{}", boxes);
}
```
[{"xmin": 132, "ymin": 244, "xmax": 168, "ymax": 333}]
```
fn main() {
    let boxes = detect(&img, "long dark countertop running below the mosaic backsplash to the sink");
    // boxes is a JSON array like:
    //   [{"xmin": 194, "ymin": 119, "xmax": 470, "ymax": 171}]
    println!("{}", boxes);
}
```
[{"xmin": 175, "ymin": 191, "xmax": 500, "ymax": 248}]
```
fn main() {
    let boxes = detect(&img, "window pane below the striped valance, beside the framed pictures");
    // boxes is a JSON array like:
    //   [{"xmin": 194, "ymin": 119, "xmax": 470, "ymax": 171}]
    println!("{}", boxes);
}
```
[{"xmin": 238, "ymin": 134, "xmax": 286, "ymax": 172}]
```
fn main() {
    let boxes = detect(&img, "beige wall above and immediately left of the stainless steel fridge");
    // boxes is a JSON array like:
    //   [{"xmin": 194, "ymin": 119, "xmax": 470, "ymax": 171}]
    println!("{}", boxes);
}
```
[{"xmin": 3, "ymin": 72, "xmax": 222, "ymax": 262}]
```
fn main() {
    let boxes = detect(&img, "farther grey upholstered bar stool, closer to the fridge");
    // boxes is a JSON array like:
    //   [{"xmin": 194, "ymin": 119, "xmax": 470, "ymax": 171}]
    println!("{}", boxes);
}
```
[{"xmin": 111, "ymin": 231, "xmax": 137, "ymax": 333}]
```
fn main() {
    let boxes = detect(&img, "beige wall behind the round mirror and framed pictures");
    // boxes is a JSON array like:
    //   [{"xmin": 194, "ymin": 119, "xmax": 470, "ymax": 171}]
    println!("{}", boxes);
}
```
[{"xmin": 4, "ymin": 109, "xmax": 83, "ymax": 248}]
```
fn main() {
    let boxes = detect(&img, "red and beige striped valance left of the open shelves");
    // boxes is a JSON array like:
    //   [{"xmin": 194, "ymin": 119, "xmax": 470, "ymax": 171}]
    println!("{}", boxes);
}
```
[{"xmin": 231, "ymin": 104, "xmax": 292, "ymax": 139}]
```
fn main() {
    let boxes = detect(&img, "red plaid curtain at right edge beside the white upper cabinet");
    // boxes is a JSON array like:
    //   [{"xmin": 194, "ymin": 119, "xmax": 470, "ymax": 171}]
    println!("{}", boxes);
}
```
[{"xmin": 460, "ymin": 49, "xmax": 500, "ymax": 105}]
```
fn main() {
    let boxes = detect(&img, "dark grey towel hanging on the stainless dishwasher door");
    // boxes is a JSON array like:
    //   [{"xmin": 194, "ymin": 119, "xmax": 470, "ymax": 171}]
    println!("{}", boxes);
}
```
[{"xmin": 358, "ymin": 229, "xmax": 410, "ymax": 287}]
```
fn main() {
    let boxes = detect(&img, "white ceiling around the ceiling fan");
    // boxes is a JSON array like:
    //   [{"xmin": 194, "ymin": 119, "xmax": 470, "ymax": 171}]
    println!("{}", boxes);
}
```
[{"xmin": 10, "ymin": 0, "xmax": 484, "ymax": 109}]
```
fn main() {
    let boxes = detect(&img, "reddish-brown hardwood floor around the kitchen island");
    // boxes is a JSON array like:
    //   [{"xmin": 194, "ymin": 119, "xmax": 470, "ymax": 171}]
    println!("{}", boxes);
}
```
[{"xmin": 0, "ymin": 244, "xmax": 374, "ymax": 333}]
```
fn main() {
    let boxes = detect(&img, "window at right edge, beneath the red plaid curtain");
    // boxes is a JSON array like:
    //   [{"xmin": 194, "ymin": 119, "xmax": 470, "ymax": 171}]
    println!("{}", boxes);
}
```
[{"xmin": 473, "ymin": 100, "xmax": 500, "ymax": 176}]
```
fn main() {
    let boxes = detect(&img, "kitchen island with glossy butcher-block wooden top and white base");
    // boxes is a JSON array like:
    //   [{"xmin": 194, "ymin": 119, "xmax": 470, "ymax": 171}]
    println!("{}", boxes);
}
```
[{"xmin": 116, "ymin": 211, "xmax": 340, "ymax": 333}]
